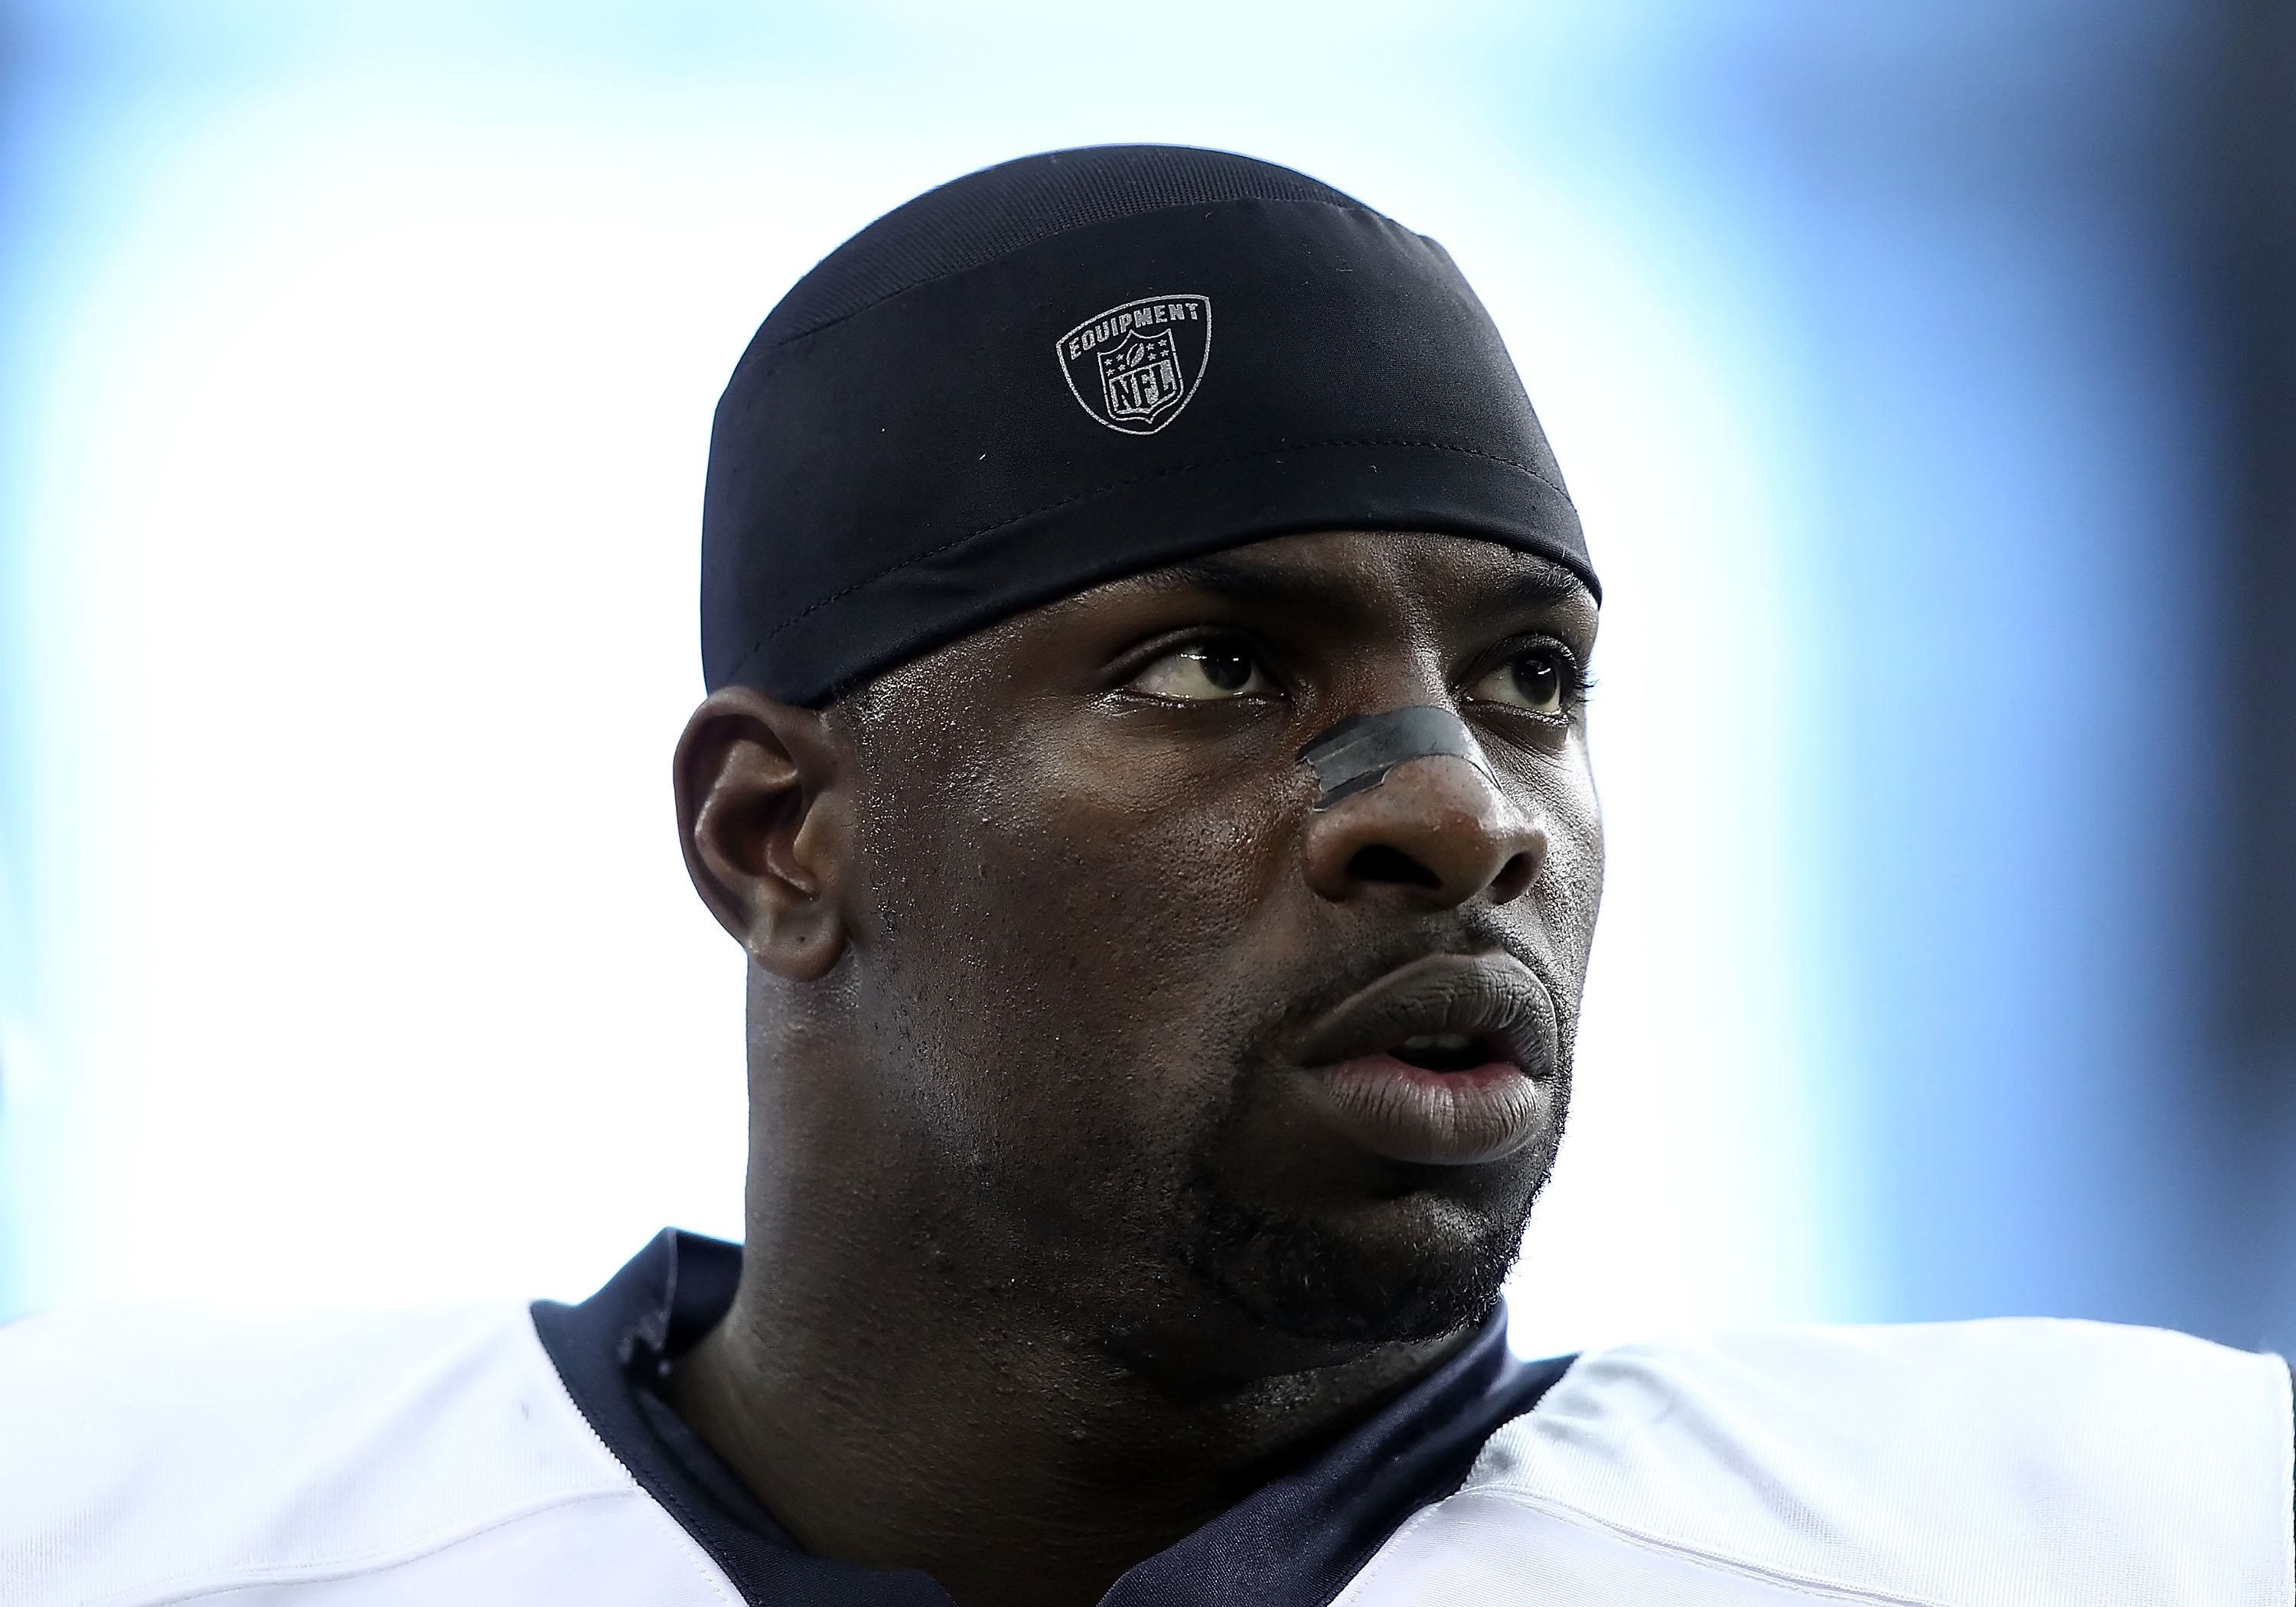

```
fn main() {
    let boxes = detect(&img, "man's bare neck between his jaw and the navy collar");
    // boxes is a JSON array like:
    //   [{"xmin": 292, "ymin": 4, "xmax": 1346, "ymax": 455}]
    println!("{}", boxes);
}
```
[{"xmin": 670, "ymin": 992, "xmax": 1465, "ymax": 1607}]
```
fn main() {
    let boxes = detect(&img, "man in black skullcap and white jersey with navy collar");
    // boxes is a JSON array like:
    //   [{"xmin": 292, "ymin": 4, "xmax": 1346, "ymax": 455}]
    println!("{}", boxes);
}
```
[{"xmin": 0, "ymin": 147, "xmax": 2296, "ymax": 1607}]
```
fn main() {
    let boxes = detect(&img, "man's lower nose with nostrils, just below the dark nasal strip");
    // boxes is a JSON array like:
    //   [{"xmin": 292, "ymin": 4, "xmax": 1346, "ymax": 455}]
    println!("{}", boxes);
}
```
[{"xmin": 1306, "ymin": 753, "xmax": 1548, "ymax": 909}]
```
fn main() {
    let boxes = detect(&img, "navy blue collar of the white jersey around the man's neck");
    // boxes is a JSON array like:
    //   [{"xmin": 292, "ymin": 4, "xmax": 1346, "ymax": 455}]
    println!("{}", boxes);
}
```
[{"xmin": 535, "ymin": 1228, "xmax": 1570, "ymax": 1607}]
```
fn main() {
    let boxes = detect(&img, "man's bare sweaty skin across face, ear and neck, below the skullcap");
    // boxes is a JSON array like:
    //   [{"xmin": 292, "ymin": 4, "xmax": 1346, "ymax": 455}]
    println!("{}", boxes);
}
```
[{"xmin": 670, "ymin": 533, "xmax": 1603, "ymax": 1607}]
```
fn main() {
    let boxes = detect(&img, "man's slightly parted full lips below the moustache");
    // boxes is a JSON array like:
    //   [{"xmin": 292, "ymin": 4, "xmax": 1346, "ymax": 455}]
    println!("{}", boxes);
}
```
[{"xmin": 1297, "ymin": 955, "xmax": 1557, "ymax": 1166}]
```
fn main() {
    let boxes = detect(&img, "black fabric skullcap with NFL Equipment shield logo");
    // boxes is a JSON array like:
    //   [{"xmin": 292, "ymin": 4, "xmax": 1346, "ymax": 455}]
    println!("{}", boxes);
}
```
[{"xmin": 703, "ymin": 145, "xmax": 1600, "ymax": 705}]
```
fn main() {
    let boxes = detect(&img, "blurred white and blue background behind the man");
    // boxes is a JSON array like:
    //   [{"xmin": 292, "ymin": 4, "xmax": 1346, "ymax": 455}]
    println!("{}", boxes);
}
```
[{"xmin": 0, "ymin": 0, "xmax": 2296, "ymax": 1350}]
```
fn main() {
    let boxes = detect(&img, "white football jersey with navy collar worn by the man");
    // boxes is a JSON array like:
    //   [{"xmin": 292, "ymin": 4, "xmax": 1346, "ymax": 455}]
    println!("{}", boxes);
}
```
[{"xmin": 0, "ymin": 1235, "xmax": 2296, "ymax": 1607}]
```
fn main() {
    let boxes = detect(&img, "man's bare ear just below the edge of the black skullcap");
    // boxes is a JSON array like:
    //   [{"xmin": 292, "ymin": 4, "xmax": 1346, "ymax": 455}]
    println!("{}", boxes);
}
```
[{"xmin": 675, "ymin": 686, "xmax": 850, "ymax": 983}]
